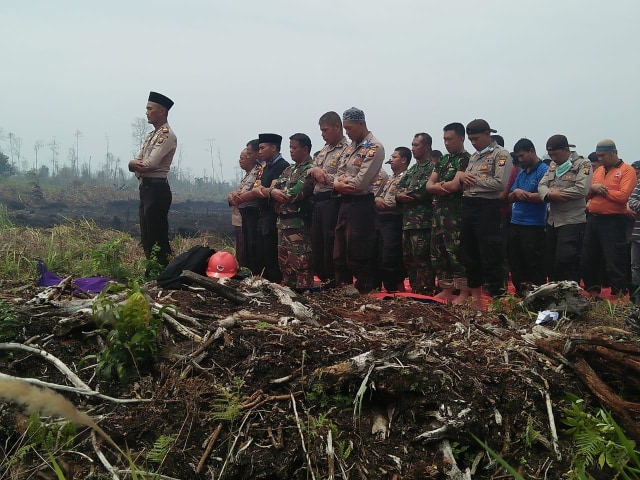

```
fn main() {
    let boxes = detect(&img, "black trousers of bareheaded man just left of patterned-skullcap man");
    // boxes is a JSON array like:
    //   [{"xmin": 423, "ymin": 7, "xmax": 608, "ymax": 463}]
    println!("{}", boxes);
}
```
[{"xmin": 311, "ymin": 197, "xmax": 340, "ymax": 282}]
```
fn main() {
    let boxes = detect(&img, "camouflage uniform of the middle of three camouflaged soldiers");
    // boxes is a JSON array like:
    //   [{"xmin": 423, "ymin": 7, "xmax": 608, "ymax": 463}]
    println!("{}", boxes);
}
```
[{"xmin": 396, "ymin": 160, "xmax": 435, "ymax": 294}]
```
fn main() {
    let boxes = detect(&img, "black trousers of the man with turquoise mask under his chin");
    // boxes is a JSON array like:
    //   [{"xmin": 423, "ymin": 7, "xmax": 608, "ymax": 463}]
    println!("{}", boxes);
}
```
[{"xmin": 545, "ymin": 223, "xmax": 585, "ymax": 282}]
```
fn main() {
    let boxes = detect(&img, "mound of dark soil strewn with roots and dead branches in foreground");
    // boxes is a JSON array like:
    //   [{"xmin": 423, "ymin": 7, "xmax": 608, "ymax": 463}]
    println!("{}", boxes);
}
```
[{"xmin": 0, "ymin": 280, "xmax": 638, "ymax": 479}]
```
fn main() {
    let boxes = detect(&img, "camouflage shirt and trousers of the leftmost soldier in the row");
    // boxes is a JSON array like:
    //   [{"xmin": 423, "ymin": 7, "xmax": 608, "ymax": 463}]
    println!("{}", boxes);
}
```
[{"xmin": 274, "ymin": 157, "xmax": 313, "ymax": 288}]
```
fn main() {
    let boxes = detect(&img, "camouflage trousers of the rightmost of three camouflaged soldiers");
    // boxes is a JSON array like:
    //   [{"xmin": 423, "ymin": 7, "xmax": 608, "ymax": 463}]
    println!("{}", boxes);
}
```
[{"xmin": 431, "ymin": 201, "xmax": 465, "ymax": 282}]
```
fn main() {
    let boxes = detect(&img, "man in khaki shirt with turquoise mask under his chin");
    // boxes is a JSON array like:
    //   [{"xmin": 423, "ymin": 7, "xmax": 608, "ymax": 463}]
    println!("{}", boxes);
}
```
[{"xmin": 538, "ymin": 135, "xmax": 593, "ymax": 282}]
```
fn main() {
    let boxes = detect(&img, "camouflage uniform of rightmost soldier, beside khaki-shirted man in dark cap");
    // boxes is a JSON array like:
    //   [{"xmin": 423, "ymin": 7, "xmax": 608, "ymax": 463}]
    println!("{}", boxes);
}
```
[{"xmin": 431, "ymin": 151, "xmax": 469, "ymax": 284}]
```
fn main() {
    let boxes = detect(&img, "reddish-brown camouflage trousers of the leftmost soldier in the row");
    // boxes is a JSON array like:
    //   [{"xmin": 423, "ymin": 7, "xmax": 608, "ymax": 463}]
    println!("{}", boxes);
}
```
[{"xmin": 278, "ymin": 228, "xmax": 313, "ymax": 288}]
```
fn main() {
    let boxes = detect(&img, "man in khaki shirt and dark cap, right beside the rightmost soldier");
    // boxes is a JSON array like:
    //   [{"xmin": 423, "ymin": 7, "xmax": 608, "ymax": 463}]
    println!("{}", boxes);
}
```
[{"xmin": 457, "ymin": 119, "xmax": 513, "ymax": 308}]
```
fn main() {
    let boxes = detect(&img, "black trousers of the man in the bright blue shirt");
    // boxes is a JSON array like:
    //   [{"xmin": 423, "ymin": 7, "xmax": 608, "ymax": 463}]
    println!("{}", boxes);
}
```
[{"xmin": 507, "ymin": 223, "xmax": 547, "ymax": 295}]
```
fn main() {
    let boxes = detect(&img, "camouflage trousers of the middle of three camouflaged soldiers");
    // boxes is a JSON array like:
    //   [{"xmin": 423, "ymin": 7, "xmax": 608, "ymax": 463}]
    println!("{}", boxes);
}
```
[{"xmin": 402, "ymin": 228, "xmax": 435, "ymax": 295}]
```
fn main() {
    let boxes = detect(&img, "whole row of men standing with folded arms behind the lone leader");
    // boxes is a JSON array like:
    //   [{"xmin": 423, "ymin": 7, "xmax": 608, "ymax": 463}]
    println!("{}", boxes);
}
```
[{"xmin": 228, "ymin": 107, "xmax": 640, "ymax": 308}]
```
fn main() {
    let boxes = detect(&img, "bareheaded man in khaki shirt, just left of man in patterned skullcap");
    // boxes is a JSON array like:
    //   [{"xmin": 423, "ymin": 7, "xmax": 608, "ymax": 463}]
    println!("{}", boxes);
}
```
[{"xmin": 309, "ymin": 112, "xmax": 349, "ymax": 288}]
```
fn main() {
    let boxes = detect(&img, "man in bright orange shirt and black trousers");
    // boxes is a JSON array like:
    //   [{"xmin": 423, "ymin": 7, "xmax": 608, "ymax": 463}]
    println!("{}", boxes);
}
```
[{"xmin": 581, "ymin": 139, "xmax": 637, "ymax": 295}]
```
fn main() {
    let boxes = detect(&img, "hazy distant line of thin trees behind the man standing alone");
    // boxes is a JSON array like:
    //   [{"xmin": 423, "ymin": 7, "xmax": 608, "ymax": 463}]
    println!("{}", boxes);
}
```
[{"xmin": 0, "ymin": 124, "xmax": 240, "ymax": 200}]
